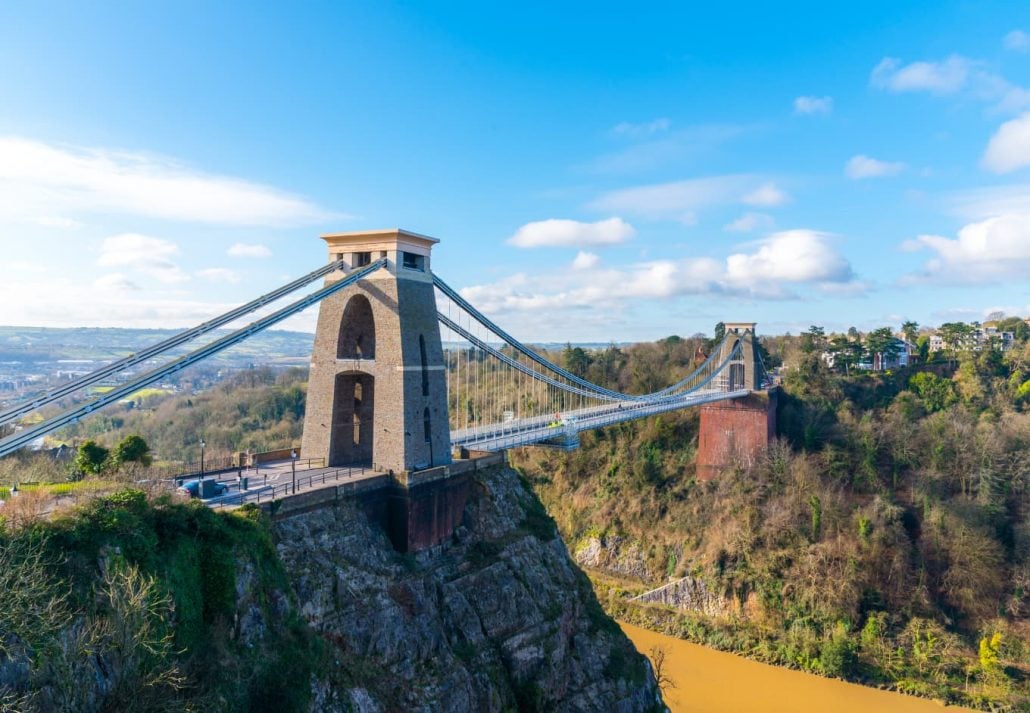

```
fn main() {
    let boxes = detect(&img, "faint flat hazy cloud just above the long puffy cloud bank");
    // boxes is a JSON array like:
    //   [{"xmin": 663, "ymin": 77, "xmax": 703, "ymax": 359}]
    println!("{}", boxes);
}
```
[{"xmin": 588, "ymin": 174, "xmax": 787, "ymax": 225}]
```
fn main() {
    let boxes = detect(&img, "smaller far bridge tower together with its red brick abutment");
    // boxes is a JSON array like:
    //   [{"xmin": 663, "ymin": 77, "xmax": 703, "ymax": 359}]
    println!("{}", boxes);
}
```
[{"xmin": 696, "ymin": 322, "xmax": 777, "ymax": 480}]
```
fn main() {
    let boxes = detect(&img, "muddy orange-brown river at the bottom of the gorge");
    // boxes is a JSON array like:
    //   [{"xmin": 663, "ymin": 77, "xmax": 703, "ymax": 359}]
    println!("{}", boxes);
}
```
[{"xmin": 620, "ymin": 623, "xmax": 972, "ymax": 713}]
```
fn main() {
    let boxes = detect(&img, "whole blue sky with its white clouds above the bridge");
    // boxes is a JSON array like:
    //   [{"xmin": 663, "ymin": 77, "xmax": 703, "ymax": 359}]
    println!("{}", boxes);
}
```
[{"xmin": 0, "ymin": 2, "xmax": 1030, "ymax": 341}]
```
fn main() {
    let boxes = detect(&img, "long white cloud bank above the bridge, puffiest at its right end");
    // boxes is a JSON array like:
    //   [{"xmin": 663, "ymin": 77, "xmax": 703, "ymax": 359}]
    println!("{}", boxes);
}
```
[{"xmin": 460, "ymin": 230, "xmax": 864, "ymax": 318}]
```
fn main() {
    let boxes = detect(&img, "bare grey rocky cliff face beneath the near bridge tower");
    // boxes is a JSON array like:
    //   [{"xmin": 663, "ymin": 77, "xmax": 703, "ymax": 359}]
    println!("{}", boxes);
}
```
[{"xmin": 271, "ymin": 468, "xmax": 660, "ymax": 713}]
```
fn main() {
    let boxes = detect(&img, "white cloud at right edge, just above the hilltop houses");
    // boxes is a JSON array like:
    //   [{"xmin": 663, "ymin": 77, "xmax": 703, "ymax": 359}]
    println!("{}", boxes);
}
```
[{"xmin": 902, "ymin": 213, "xmax": 1030, "ymax": 283}]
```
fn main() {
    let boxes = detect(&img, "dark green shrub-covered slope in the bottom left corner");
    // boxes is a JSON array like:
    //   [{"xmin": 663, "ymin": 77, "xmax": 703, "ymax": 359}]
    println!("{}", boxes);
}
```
[{"xmin": 0, "ymin": 490, "xmax": 324, "ymax": 711}]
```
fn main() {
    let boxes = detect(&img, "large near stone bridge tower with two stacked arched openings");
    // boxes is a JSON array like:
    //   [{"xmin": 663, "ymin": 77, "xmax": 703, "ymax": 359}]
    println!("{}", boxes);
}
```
[{"xmin": 302, "ymin": 229, "xmax": 450, "ymax": 473}]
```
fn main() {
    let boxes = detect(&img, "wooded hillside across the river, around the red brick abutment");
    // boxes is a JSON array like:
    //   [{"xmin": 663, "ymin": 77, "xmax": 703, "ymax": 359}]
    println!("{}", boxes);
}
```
[{"xmin": 513, "ymin": 329, "xmax": 1030, "ymax": 709}]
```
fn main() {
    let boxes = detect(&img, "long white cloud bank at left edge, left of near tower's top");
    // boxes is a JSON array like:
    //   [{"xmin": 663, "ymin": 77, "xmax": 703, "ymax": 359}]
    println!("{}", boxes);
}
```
[{"xmin": 0, "ymin": 137, "xmax": 332, "ymax": 226}]
